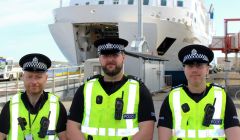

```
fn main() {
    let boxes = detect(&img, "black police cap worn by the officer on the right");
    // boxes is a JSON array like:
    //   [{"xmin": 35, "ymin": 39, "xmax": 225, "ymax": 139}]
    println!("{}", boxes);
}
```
[{"xmin": 178, "ymin": 44, "xmax": 214, "ymax": 64}]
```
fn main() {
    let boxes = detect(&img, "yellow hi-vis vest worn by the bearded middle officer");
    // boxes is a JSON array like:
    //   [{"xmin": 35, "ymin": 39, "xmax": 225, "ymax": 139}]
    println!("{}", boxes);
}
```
[{"xmin": 81, "ymin": 79, "xmax": 139, "ymax": 140}]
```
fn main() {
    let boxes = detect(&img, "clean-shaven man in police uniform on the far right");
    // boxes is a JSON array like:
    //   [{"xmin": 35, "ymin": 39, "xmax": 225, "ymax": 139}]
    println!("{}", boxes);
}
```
[{"xmin": 158, "ymin": 44, "xmax": 240, "ymax": 140}]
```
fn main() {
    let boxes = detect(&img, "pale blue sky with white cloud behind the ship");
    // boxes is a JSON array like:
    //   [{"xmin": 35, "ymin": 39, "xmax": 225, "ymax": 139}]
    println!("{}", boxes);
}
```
[{"xmin": 0, "ymin": 0, "xmax": 240, "ymax": 61}]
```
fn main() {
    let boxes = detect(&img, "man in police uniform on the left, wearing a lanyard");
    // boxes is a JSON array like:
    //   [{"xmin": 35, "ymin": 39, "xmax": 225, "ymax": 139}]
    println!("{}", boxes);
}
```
[{"xmin": 0, "ymin": 53, "xmax": 67, "ymax": 140}]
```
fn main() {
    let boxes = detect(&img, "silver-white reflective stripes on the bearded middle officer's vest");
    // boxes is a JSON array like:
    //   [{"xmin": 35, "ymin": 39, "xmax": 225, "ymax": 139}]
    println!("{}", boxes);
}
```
[{"xmin": 81, "ymin": 79, "xmax": 139, "ymax": 136}]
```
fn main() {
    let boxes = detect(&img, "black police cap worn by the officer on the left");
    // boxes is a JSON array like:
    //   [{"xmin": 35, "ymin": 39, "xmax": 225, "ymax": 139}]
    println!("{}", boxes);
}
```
[{"xmin": 19, "ymin": 53, "xmax": 51, "ymax": 72}]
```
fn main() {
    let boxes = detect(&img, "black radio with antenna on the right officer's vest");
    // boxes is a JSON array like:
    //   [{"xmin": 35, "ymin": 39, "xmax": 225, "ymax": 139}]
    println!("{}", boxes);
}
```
[{"xmin": 202, "ymin": 102, "xmax": 215, "ymax": 127}]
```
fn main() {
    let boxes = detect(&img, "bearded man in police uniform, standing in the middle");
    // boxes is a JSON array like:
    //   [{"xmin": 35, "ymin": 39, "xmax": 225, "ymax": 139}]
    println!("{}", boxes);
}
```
[{"xmin": 67, "ymin": 38, "xmax": 155, "ymax": 140}]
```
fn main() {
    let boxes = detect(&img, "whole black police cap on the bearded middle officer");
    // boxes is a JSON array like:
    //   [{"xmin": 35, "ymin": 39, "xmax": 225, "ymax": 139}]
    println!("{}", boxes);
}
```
[{"xmin": 94, "ymin": 38, "xmax": 128, "ymax": 55}]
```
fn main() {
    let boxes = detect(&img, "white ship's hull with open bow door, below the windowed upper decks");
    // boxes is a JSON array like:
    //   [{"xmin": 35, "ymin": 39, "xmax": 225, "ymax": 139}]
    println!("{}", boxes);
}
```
[{"xmin": 49, "ymin": 5, "xmax": 211, "ymax": 83}]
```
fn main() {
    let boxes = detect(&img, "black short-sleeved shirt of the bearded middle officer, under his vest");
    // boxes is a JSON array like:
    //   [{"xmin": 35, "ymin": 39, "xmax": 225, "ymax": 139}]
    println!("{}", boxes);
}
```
[{"xmin": 68, "ymin": 76, "xmax": 156, "ymax": 124}]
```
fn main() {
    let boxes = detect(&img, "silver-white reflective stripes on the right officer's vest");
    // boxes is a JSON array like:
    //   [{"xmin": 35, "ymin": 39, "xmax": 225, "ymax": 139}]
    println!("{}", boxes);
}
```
[{"xmin": 172, "ymin": 87, "xmax": 225, "ymax": 138}]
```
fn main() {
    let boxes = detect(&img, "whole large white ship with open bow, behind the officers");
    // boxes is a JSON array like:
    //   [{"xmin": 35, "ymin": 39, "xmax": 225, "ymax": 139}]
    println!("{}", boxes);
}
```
[{"xmin": 49, "ymin": 0, "xmax": 213, "ymax": 86}]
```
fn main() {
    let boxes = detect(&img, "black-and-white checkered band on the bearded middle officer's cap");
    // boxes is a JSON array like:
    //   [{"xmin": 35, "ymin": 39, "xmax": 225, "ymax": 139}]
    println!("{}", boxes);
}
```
[{"xmin": 98, "ymin": 43, "xmax": 124, "ymax": 54}]
